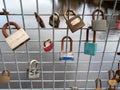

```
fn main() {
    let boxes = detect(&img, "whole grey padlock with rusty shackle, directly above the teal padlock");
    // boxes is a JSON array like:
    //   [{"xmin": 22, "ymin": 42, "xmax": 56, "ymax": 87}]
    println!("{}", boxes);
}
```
[{"xmin": 92, "ymin": 9, "xmax": 107, "ymax": 31}]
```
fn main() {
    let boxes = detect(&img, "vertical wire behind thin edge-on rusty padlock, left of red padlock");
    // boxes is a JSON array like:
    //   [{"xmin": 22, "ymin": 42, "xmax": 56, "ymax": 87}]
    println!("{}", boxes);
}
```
[{"xmin": 36, "ymin": 0, "xmax": 44, "ymax": 90}]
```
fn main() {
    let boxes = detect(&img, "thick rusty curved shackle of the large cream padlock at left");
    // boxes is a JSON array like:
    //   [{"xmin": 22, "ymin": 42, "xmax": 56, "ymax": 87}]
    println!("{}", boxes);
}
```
[{"xmin": 2, "ymin": 22, "xmax": 20, "ymax": 38}]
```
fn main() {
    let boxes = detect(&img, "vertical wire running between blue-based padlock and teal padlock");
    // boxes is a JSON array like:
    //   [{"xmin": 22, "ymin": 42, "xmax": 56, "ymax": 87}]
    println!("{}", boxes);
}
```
[{"xmin": 75, "ymin": 0, "xmax": 86, "ymax": 87}]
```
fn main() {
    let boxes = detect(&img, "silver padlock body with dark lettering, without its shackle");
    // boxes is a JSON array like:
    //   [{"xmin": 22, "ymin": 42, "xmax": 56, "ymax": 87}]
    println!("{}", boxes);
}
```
[{"xmin": 27, "ymin": 68, "xmax": 40, "ymax": 79}]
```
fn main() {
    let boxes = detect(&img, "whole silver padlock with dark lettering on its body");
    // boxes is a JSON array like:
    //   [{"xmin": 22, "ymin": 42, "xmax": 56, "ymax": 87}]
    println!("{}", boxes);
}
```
[{"xmin": 27, "ymin": 60, "xmax": 40, "ymax": 79}]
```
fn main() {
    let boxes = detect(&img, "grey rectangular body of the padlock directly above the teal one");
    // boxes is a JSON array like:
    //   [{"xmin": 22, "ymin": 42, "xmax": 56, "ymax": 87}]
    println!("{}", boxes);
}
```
[{"xmin": 92, "ymin": 20, "xmax": 107, "ymax": 31}]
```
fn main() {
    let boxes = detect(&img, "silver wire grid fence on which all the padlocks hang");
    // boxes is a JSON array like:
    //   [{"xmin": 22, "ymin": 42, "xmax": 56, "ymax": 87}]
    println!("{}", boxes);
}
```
[{"xmin": 0, "ymin": 0, "xmax": 120, "ymax": 90}]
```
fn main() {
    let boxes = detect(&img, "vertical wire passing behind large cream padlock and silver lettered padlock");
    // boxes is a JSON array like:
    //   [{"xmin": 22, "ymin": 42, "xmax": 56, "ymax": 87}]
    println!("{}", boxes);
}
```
[{"xmin": 20, "ymin": 0, "xmax": 33, "ymax": 90}]
